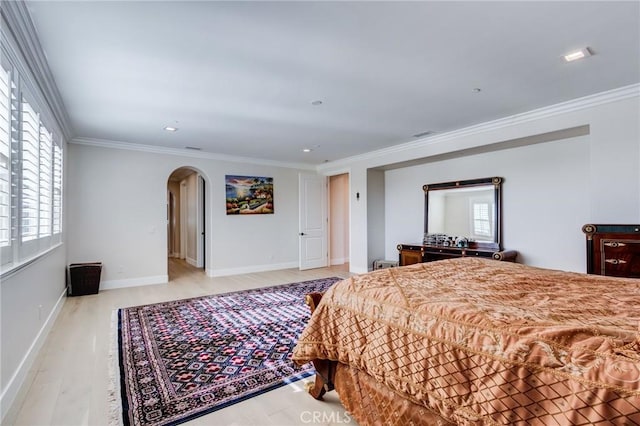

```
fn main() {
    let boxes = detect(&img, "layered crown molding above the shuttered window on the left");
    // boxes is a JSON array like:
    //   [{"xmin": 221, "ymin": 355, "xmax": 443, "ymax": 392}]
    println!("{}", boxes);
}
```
[{"xmin": 1, "ymin": 0, "xmax": 73, "ymax": 140}]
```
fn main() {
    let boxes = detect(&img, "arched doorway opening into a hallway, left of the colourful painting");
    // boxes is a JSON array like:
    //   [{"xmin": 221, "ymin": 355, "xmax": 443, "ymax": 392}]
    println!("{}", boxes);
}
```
[{"xmin": 167, "ymin": 166, "xmax": 208, "ymax": 281}]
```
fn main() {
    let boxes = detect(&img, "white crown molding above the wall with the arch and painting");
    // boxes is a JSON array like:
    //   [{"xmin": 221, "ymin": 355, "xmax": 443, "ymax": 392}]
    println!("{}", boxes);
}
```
[{"xmin": 69, "ymin": 138, "xmax": 317, "ymax": 170}]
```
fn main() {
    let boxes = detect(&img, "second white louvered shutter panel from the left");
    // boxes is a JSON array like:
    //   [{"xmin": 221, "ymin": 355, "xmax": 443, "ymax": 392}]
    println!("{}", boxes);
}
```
[{"xmin": 20, "ymin": 99, "xmax": 40, "ymax": 242}]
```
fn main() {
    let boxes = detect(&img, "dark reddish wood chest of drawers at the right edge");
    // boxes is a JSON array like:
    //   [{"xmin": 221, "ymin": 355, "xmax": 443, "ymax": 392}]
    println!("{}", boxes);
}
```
[{"xmin": 582, "ymin": 224, "xmax": 640, "ymax": 278}]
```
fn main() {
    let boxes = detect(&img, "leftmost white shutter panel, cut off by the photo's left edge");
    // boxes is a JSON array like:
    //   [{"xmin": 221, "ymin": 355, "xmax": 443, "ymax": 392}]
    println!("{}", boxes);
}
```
[{"xmin": 0, "ymin": 67, "xmax": 11, "ymax": 247}]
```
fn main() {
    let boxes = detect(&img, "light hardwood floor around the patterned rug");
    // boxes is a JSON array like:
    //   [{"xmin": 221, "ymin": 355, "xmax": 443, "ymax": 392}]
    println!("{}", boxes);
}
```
[{"xmin": 3, "ymin": 259, "xmax": 356, "ymax": 426}]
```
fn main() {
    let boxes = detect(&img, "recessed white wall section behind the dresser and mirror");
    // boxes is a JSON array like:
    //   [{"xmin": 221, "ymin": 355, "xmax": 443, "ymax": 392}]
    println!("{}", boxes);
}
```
[{"xmin": 385, "ymin": 136, "xmax": 590, "ymax": 271}]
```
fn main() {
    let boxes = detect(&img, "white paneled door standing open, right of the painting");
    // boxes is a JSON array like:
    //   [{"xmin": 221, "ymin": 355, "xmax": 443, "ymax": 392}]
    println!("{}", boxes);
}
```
[{"xmin": 299, "ymin": 173, "xmax": 329, "ymax": 270}]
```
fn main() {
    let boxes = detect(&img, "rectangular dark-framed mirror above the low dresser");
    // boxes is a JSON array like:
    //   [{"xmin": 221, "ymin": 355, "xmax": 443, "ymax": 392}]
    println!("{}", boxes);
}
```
[{"xmin": 422, "ymin": 177, "xmax": 502, "ymax": 250}]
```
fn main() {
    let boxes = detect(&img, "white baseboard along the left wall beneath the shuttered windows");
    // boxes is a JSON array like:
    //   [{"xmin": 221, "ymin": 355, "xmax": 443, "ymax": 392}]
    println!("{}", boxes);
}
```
[{"xmin": 0, "ymin": 288, "xmax": 67, "ymax": 424}]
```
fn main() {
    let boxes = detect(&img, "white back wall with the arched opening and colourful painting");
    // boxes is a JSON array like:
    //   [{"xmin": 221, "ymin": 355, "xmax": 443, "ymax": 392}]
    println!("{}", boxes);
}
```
[{"xmin": 66, "ymin": 144, "xmax": 310, "ymax": 288}]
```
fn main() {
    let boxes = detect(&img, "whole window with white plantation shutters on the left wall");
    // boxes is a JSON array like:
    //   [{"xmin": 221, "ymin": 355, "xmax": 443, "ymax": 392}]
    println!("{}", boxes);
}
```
[{"xmin": 0, "ymin": 44, "xmax": 63, "ymax": 273}]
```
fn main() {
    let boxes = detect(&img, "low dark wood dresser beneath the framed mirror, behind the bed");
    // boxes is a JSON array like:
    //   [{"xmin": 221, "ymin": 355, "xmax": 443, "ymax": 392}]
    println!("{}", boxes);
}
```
[{"xmin": 397, "ymin": 244, "xmax": 518, "ymax": 266}]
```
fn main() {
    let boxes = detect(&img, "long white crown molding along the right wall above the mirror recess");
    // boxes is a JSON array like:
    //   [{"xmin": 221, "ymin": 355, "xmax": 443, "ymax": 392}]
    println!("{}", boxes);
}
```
[{"xmin": 317, "ymin": 84, "xmax": 640, "ymax": 173}]
